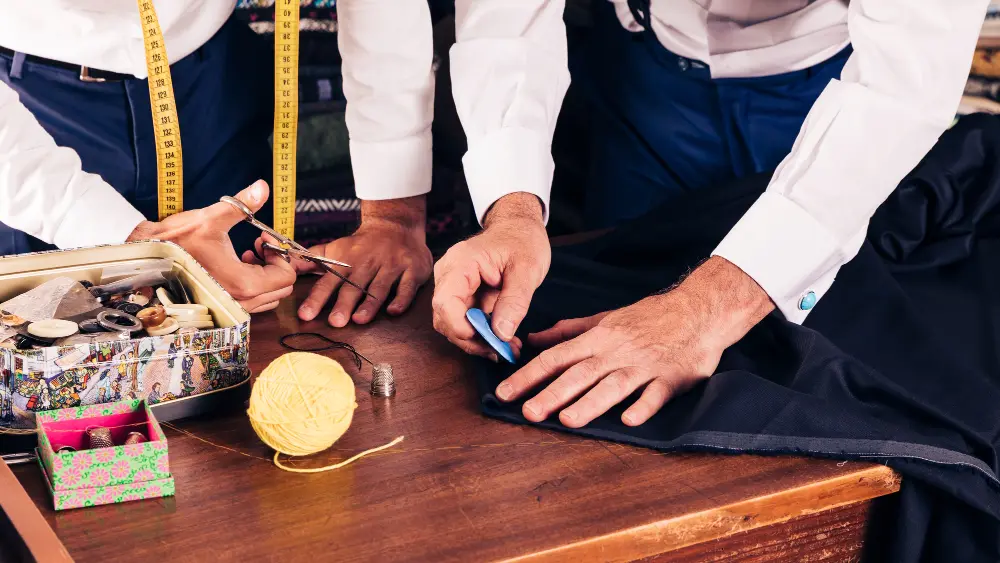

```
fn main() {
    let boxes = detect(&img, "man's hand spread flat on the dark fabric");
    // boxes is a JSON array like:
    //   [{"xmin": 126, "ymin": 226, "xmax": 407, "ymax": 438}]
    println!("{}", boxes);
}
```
[{"xmin": 496, "ymin": 257, "xmax": 774, "ymax": 428}]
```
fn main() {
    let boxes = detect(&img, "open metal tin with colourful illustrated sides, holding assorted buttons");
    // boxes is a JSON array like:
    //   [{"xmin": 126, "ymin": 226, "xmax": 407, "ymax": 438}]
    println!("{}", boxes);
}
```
[{"xmin": 0, "ymin": 241, "xmax": 250, "ymax": 429}]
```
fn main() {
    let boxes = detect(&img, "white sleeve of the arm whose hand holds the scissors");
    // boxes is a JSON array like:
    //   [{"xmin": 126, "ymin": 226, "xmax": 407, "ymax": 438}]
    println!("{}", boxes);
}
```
[{"xmin": 0, "ymin": 82, "xmax": 144, "ymax": 248}]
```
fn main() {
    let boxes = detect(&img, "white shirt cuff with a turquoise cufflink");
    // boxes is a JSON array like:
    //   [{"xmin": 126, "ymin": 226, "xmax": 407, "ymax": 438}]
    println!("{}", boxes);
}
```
[{"xmin": 712, "ymin": 192, "xmax": 848, "ymax": 323}]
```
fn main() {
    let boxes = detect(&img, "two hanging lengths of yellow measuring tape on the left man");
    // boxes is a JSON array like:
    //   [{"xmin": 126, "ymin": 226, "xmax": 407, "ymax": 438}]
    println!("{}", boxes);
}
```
[{"xmin": 137, "ymin": 0, "xmax": 299, "ymax": 239}]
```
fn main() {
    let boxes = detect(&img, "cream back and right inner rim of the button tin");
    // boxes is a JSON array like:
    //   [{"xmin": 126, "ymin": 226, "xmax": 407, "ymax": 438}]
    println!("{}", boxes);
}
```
[{"xmin": 0, "ymin": 241, "xmax": 250, "ymax": 324}]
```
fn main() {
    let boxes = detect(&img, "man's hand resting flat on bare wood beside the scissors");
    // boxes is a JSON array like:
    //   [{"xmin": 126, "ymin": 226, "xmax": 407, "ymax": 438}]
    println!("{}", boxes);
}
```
[{"xmin": 276, "ymin": 196, "xmax": 434, "ymax": 327}]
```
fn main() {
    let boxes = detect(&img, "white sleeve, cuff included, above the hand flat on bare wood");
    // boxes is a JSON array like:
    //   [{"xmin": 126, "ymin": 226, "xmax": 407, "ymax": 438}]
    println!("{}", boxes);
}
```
[{"xmin": 337, "ymin": 0, "xmax": 434, "ymax": 200}]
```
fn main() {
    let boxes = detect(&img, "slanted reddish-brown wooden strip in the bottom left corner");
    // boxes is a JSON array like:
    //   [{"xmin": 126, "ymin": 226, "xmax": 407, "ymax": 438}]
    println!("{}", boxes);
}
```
[{"xmin": 0, "ymin": 461, "xmax": 73, "ymax": 563}]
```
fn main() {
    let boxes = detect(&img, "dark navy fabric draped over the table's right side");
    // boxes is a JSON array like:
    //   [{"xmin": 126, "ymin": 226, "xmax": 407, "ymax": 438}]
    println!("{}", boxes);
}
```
[{"xmin": 477, "ymin": 115, "xmax": 1000, "ymax": 562}]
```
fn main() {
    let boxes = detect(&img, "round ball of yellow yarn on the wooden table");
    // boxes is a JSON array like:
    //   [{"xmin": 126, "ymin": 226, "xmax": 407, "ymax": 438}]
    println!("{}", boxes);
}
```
[{"xmin": 247, "ymin": 352, "xmax": 358, "ymax": 455}]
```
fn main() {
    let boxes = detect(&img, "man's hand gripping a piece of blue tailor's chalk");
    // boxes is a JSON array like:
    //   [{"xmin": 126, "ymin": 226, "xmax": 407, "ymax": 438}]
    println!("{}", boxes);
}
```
[{"xmin": 433, "ymin": 193, "xmax": 552, "ymax": 361}]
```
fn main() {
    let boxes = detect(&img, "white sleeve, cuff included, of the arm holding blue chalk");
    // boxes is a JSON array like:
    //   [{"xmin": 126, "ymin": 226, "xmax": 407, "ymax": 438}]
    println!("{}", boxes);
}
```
[{"xmin": 451, "ymin": 0, "xmax": 569, "ymax": 222}]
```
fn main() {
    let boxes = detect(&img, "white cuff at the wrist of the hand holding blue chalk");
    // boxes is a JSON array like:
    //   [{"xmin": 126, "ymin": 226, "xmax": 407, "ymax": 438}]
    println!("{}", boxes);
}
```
[{"xmin": 462, "ymin": 127, "xmax": 555, "ymax": 224}]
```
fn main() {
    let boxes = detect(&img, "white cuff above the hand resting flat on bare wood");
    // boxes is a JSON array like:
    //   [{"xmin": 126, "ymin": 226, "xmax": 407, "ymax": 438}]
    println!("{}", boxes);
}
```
[{"xmin": 351, "ymin": 131, "xmax": 433, "ymax": 200}]
